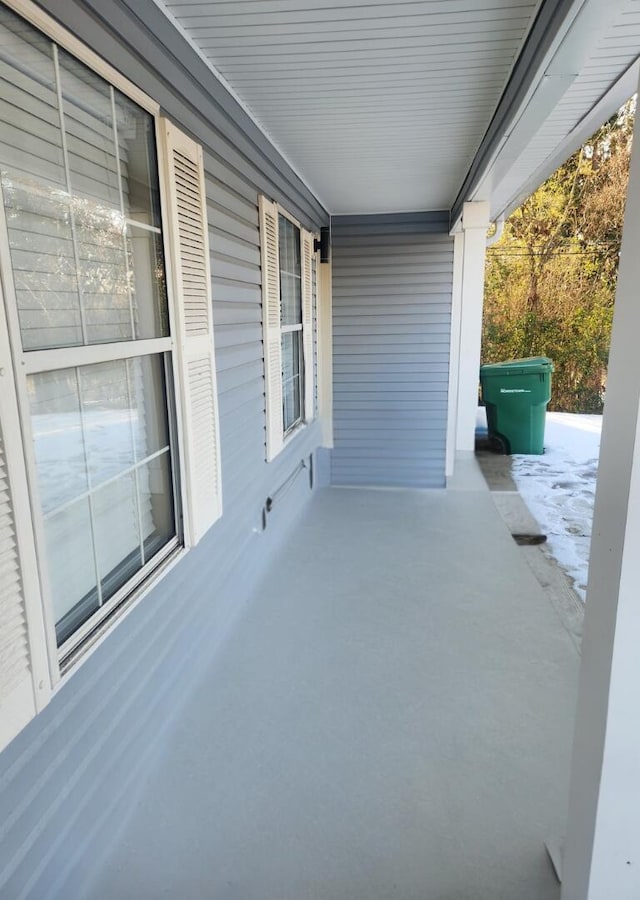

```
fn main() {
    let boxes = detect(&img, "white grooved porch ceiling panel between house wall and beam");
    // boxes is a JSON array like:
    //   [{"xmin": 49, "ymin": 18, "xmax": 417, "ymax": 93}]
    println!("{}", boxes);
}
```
[{"xmin": 163, "ymin": 0, "xmax": 539, "ymax": 214}]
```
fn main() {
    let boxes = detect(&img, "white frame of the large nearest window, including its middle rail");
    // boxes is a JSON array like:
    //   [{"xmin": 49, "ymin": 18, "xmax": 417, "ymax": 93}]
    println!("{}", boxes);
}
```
[{"xmin": 0, "ymin": 0, "xmax": 198, "ymax": 688}]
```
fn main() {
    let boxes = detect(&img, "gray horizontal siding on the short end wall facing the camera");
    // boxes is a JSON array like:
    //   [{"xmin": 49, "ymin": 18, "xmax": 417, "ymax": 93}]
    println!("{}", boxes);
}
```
[{"xmin": 331, "ymin": 229, "xmax": 453, "ymax": 487}]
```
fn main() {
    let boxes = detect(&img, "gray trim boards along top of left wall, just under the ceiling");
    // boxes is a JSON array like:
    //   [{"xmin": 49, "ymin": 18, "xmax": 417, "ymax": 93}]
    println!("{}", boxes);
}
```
[{"xmin": 43, "ymin": 0, "xmax": 329, "ymax": 229}]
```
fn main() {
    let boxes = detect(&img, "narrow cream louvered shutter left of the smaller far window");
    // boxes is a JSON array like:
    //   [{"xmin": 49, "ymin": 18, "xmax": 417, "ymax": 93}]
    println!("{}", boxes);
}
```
[{"xmin": 259, "ymin": 197, "xmax": 284, "ymax": 460}]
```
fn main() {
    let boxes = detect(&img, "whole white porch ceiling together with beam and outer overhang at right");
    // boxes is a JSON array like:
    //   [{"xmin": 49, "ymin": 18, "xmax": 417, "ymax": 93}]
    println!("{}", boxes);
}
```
[{"xmin": 156, "ymin": 0, "xmax": 640, "ymax": 224}]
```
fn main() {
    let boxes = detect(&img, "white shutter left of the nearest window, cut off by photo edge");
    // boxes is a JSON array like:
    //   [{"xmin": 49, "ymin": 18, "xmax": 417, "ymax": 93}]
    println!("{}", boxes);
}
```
[{"xmin": 0, "ymin": 304, "xmax": 51, "ymax": 750}]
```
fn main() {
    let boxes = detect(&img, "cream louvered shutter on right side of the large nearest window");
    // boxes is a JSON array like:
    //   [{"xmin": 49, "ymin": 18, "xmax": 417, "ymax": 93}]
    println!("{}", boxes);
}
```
[{"xmin": 161, "ymin": 119, "xmax": 222, "ymax": 544}]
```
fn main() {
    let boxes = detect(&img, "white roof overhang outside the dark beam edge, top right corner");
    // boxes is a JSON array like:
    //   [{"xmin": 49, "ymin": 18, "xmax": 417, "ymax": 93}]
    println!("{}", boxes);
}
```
[{"xmin": 451, "ymin": 0, "xmax": 640, "ymax": 228}]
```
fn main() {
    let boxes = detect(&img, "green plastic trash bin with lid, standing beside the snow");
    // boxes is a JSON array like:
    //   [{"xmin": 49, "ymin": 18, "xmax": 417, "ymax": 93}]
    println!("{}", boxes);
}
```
[{"xmin": 480, "ymin": 356, "xmax": 553, "ymax": 454}]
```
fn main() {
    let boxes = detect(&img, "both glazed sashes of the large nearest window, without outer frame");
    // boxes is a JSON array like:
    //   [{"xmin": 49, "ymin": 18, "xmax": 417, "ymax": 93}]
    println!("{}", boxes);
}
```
[{"xmin": 0, "ymin": 1, "xmax": 178, "ymax": 644}]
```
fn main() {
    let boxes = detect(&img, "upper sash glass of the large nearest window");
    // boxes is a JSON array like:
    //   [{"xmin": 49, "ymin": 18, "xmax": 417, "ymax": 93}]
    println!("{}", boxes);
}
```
[{"xmin": 0, "ymin": 8, "xmax": 169, "ymax": 350}]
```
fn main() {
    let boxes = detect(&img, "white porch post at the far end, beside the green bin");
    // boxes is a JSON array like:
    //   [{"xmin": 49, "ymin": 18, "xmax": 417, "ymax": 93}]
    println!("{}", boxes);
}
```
[{"xmin": 449, "ymin": 200, "xmax": 489, "ymax": 452}]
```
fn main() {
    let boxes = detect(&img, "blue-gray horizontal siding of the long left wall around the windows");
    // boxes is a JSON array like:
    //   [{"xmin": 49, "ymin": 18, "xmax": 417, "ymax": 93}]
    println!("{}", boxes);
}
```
[{"xmin": 0, "ymin": 0, "xmax": 326, "ymax": 900}]
